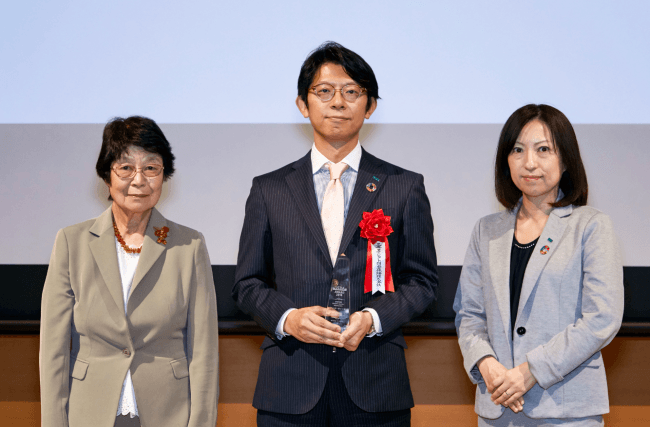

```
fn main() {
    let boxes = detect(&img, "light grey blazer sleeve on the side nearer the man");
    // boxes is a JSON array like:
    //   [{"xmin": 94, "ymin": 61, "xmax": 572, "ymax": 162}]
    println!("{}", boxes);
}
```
[{"xmin": 454, "ymin": 221, "xmax": 497, "ymax": 384}]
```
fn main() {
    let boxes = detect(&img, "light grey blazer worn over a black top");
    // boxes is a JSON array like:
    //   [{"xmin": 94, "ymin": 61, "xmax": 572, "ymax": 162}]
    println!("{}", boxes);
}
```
[{"xmin": 454, "ymin": 202, "xmax": 623, "ymax": 419}]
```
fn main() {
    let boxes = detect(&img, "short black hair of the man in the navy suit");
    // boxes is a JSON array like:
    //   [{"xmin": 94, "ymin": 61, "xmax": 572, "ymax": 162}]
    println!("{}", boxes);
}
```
[{"xmin": 298, "ymin": 42, "xmax": 380, "ymax": 111}]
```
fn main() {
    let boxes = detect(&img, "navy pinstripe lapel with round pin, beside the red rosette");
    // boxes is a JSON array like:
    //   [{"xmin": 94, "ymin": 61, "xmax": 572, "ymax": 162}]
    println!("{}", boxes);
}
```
[{"xmin": 338, "ymin": 148, "xmax": 386, "ymax": 255}]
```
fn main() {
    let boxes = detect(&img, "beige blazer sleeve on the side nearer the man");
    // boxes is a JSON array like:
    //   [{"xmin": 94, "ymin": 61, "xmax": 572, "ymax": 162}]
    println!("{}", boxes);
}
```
[{"xmin": 187, "ymin": 235, "xmax": 219, "ymax": 427}]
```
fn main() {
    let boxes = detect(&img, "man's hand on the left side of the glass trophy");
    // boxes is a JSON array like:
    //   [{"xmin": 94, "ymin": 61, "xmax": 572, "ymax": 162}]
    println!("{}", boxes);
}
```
[{"xmin": 284, "ymin": 305, "xmax": 343, "ymax": 347}]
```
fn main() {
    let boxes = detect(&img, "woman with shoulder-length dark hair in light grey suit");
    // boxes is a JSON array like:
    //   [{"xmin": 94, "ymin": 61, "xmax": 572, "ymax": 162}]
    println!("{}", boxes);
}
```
[{"xmin": 454, "ymin": 104, "xmax": 623, "ymax": 427}]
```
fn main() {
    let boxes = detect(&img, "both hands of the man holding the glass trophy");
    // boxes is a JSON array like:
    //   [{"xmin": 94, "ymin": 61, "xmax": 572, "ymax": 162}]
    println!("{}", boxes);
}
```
[{"xmin": 284, "ymin": 305, "xmax": 372, "ymax": 351}]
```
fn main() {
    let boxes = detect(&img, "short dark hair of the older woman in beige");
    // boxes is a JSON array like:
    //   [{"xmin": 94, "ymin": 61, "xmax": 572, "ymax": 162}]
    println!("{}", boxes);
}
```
[{"xmin": 95, "ymin": 116, "xmax": 175, "ymax": 184}]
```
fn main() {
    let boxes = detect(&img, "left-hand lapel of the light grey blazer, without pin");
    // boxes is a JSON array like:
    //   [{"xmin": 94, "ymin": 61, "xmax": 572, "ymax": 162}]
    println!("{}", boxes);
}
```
[{"xmin": 488, "ymin": 209, "xmax": 517, "ymax": 343}]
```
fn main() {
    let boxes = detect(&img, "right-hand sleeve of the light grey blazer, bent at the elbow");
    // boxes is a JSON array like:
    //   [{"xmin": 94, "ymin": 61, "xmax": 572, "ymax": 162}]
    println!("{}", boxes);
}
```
[{"xmin": 526, "ymin": 212, "xmax": 623, "ymax": 389}]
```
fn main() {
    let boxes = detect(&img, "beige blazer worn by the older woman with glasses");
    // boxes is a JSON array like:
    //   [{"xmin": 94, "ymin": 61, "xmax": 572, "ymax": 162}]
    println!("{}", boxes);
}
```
[{"xmin": 39, "ymin": 208, "xmax": 218, "ymax": 427}]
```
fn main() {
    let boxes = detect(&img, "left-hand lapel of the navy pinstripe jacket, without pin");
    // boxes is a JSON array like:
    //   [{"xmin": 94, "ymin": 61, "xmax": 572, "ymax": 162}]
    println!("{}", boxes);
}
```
[{"xmin": 285, "ymin": 151, "xmax": 332, "ymax": 265}]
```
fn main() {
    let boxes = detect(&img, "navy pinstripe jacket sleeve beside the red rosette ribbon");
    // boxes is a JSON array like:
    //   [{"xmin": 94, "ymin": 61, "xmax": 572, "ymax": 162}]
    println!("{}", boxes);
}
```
[{"xmin": 365, "ymin": 175, "xmax": 438, "ymax": 336}]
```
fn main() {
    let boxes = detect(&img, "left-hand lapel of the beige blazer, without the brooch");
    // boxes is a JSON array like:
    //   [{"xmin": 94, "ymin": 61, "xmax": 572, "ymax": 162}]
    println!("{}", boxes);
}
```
[{"xmin": 89, "ymin": 208, "xmax": 126, "ymax": 325}]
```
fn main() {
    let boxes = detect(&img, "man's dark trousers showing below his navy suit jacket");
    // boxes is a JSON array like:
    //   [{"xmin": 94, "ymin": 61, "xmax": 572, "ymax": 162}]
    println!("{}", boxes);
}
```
[{"xmin": 257, "ymin": 352, "xmax": 411, "ymax": 427}]
